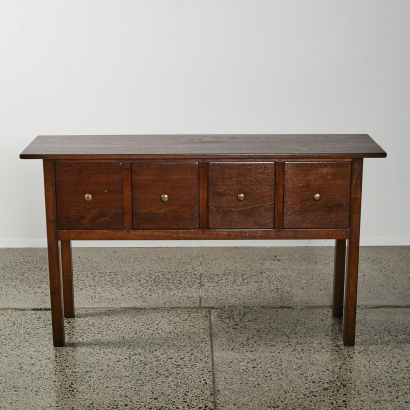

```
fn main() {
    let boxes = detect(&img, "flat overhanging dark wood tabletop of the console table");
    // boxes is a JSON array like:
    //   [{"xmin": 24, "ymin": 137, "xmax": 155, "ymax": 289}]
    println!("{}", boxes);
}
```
[{"xmin": 20, "ymin": 134, "xmax": 386, "ymax": 161}]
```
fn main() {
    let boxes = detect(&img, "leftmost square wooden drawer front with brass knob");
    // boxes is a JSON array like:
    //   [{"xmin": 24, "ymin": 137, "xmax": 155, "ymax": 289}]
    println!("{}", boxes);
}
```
[{"xmin": 55, "ymin": 162, "xmax": 124, "ymax": 229}]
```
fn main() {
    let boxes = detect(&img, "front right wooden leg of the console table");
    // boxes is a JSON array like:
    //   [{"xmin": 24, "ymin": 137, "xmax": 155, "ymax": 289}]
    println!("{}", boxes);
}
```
[{"xmin": 343, "ymin": 159, "xmax": 363, "ymax": 346}]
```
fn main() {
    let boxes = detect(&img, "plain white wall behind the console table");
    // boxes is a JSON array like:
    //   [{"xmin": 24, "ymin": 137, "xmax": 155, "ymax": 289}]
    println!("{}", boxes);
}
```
[{"xmin": 0, "ymin": 0, "xmax": 410, "ymax": 247}]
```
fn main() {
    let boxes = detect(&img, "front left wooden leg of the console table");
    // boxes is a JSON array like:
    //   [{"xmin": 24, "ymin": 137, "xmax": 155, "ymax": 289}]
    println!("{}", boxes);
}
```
[{"xmin": 43, "ymin": 160, "xmax": 65, "ymax": 347}]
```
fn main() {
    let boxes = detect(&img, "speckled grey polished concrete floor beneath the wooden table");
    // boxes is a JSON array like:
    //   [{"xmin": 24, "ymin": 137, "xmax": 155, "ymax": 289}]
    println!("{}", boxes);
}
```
[{"xmin": 0, "ymin": 247, "xmax": 410, "ymax": 410}]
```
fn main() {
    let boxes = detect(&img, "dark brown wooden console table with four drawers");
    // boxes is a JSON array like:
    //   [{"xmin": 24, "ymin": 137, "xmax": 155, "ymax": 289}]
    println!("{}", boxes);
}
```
[{"xmin": 20, "ymin": 134, "xmax": 386, "ymax": 346}]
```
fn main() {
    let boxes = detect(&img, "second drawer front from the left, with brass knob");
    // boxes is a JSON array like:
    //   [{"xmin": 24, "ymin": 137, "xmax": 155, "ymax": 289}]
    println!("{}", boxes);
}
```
[{"xmin": 132, "ymin": 162, "xmax": 199, "ymax": 229}]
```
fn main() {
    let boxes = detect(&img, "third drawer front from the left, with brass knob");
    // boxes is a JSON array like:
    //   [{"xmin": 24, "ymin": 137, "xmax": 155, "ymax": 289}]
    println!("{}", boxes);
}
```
[{"xmin": 208, "ymin": 162, "xmax": 275, "ymax": 229}]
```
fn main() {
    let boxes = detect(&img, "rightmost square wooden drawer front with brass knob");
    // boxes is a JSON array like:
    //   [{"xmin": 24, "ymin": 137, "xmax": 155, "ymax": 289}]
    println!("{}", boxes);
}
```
[{"xmin": 283, "ymin": 162, "xmax": 351, "ymax": 229}]
